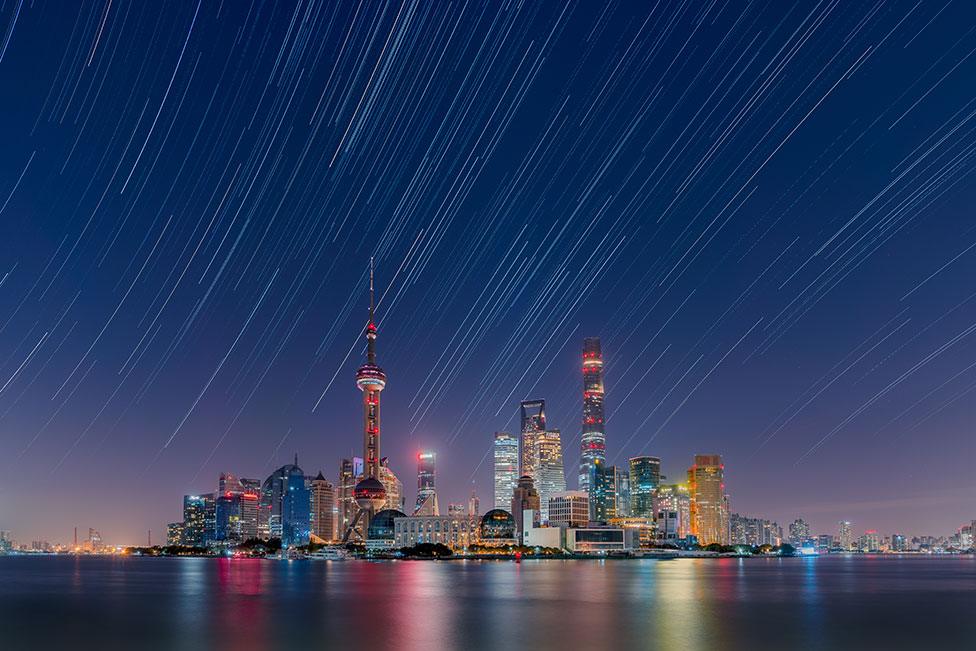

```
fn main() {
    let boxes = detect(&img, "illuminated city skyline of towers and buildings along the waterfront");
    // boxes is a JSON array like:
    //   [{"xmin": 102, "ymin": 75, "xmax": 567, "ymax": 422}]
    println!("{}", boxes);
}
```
[{"xmin": 9, "ymin": 269, "xmax": 976, "ymax": 553}]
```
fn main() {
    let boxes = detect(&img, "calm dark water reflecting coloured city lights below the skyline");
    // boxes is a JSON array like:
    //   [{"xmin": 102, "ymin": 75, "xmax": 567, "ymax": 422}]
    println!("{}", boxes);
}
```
[{"xmin": 0, "ymin": 557, "xmax": 976, "ymax": 651}]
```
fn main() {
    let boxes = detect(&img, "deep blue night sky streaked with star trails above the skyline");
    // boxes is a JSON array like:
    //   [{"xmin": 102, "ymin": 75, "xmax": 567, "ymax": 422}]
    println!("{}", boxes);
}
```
[{"xmin": 0, "ymin": 0, "xmax": 976, "ymax": 543}]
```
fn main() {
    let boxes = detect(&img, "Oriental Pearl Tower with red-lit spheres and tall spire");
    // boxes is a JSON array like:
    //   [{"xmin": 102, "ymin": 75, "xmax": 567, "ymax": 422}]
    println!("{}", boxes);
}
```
[{"xmin": 342, "ymin": 258, "xmax": 386, "ymax": 542}]
